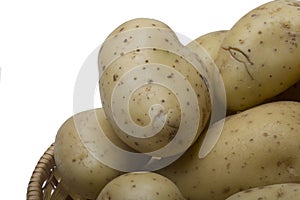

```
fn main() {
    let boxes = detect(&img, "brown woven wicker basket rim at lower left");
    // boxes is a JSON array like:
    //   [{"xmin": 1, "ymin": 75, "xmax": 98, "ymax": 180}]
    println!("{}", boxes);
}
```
[{"xmin": 27, "ymin": 144, "xmax": 73, "ymax": 200}]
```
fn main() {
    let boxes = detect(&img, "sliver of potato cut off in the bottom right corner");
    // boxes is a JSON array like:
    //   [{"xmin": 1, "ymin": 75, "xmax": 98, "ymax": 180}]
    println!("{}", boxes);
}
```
[{"xmin": 226, "ymin": 183, "xmax": 300, "ymax": 200}]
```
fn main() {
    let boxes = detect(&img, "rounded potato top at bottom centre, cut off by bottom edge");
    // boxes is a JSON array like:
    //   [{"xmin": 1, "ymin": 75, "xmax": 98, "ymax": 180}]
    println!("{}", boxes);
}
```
[{"xmin": 97, "ymin": 172, "xmax": 184, "ymax": 200}]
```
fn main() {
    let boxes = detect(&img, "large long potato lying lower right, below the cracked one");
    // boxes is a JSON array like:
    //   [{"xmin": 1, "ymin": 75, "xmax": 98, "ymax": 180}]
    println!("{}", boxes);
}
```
[{"xmin": 157, "ymin": 101, "xmax": 300, "ymax": 200}]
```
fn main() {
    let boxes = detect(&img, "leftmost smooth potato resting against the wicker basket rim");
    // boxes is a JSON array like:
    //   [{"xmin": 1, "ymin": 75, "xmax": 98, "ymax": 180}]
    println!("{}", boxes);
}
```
[{"xmin": 54, "ymin": 109, "xmax": 130, "ymax": 199}]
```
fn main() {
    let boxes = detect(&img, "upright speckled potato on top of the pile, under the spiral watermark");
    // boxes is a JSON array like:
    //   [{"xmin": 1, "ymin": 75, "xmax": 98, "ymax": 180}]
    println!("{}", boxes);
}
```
[{"xmin": 99, "ymin": 17, "xmax": 211, "ymax": 157}]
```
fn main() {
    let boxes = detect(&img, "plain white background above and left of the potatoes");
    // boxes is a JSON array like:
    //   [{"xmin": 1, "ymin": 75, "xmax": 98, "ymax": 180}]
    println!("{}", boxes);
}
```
[{"xmin": 0, "ymin": 0, "xmax": 267, "ymax": 199}]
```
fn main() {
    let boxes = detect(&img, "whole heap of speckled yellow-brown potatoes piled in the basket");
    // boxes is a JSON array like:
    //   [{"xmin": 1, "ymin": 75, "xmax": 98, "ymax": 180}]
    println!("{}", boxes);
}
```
[{"xmin": 54, "ymin": 0, "xmax": 300, "ymax": 200}]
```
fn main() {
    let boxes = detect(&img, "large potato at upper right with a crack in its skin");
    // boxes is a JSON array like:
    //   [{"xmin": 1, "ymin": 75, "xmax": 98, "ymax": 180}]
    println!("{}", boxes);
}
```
[{"xmin": 215, "ymin": 0, "xmax": 300, "ymax": 111}]
